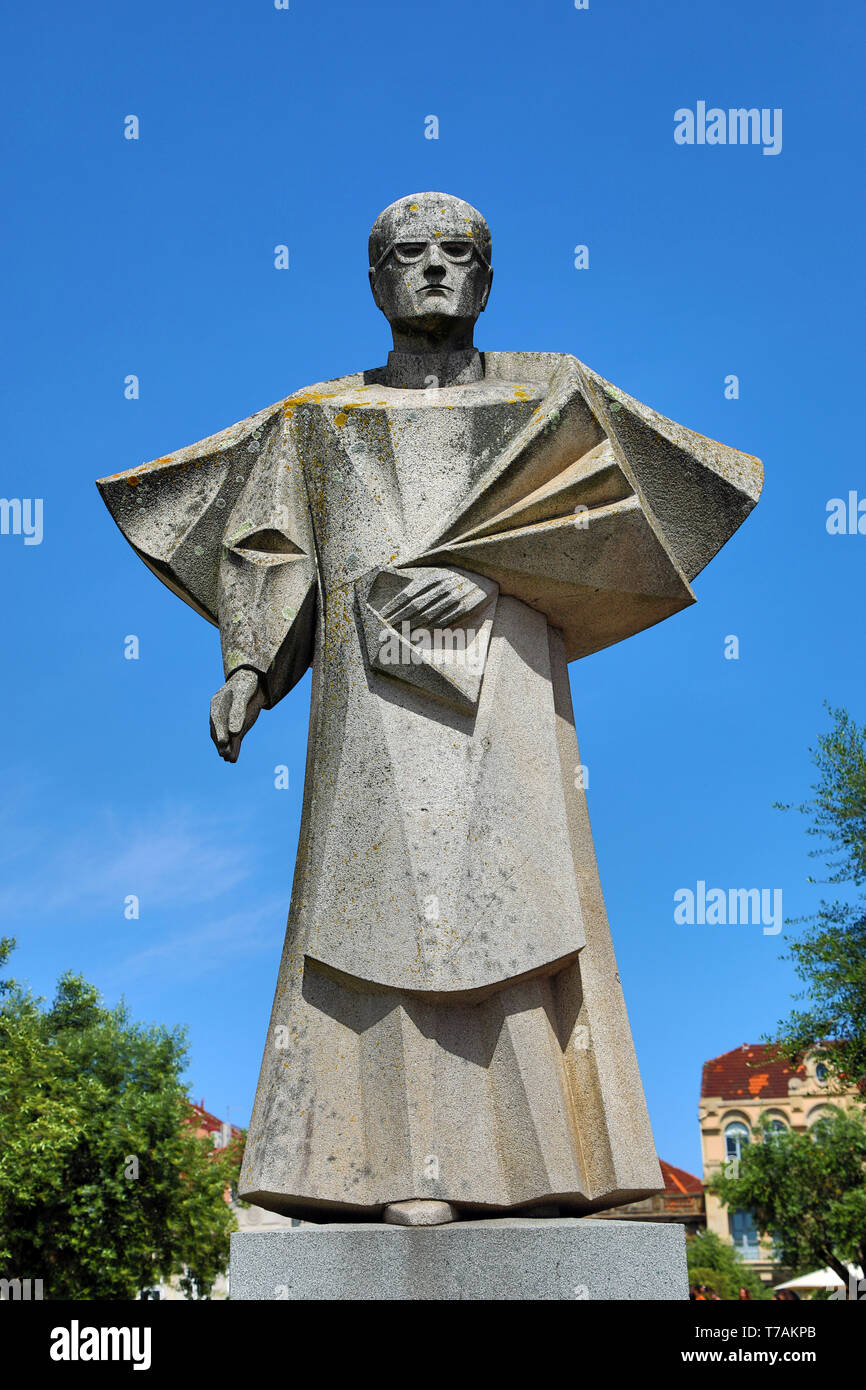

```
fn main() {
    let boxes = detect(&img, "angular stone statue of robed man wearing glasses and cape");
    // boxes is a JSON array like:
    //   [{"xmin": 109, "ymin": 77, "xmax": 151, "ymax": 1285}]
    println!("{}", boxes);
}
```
[{"xmin": 99, "ymin": 193, "xmax": 760, "ymax": 1225}]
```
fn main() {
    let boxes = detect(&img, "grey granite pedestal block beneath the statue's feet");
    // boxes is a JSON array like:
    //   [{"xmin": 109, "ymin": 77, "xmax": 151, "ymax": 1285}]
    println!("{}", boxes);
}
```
[{"xmin": 229, "ymin": 1218, "xmax": 688, "ymax": 1301}]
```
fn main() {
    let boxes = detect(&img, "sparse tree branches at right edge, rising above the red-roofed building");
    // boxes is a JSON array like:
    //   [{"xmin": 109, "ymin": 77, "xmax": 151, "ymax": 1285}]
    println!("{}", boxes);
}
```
[{"xmin": 765, "ymin": 706, "xmax": 866, "ymax": 1094}]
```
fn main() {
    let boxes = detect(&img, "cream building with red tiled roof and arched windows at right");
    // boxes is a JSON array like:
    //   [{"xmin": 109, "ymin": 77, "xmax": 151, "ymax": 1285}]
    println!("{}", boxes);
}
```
[{"xmin": 698, "ymin": 1043, "xmax": 853, "ymax": 1283}]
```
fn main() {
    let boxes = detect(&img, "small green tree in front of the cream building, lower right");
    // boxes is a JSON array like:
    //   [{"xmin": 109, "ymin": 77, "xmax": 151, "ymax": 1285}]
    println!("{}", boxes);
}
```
[{"xmin": 709, "ymin": 1106, "xmax": 866, "ymax": 1283}]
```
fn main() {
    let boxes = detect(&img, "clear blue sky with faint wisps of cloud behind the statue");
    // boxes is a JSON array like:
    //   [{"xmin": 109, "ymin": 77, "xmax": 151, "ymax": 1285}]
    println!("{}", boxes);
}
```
[{"xmin": 0, "ymin": 0, "xmax": 866, "ymax": 1170}]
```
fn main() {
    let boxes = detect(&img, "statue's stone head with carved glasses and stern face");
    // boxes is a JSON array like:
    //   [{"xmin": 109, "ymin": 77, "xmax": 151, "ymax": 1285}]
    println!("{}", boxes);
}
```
[{"xmin": 370, "ymin": 193, "xmax": 493, "ymax": 352}]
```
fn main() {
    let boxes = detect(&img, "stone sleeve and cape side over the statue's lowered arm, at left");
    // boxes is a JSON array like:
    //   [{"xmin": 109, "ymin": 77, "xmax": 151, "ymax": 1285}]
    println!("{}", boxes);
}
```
[{"xmin": 97, "ymin": 402, "xmax": 317, "ymax": 708}]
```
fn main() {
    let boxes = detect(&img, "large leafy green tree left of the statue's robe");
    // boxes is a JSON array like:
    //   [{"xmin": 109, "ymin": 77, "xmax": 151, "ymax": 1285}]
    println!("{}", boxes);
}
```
[{"xmin": 0, "ymin": 938, "xmax": 236, "ymax": 1300}]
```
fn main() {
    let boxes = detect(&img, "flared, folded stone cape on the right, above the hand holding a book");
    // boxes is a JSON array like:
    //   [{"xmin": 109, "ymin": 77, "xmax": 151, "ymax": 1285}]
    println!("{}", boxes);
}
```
[{"xmin": 402, "ymin": 356, "xmax": 762, "ymax": 662}]
